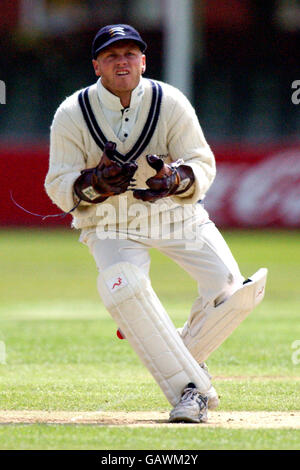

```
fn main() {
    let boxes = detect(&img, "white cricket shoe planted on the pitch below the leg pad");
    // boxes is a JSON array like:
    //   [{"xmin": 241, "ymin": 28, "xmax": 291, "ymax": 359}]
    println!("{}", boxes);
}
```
[{"xmin": 169, "ymin": 383, "xmax": 208, "ymax": 423}]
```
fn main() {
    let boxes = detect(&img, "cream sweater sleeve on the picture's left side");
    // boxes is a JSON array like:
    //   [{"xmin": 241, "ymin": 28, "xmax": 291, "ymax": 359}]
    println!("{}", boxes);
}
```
[{"xmin": 45, "ymin": 108, "xmax": 86, "ymax": 212}]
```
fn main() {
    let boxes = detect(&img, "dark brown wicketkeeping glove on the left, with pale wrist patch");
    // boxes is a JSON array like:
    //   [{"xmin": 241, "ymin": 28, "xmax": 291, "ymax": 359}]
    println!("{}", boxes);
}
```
[{"xmin": 74, "ymin": 142, "xmax": 137, "ymax": 204}]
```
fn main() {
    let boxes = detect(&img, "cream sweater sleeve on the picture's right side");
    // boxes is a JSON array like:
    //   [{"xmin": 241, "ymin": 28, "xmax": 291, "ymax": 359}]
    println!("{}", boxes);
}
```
[{"xmin": 168, "ymin": 92, "xmax": 216, "ymax": 204}]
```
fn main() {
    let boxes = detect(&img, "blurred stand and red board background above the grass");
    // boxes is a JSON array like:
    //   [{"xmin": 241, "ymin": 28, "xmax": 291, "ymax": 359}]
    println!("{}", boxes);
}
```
[{"xmin": 0, "ymin": 0, "xmax": 300, "ymax": 228}]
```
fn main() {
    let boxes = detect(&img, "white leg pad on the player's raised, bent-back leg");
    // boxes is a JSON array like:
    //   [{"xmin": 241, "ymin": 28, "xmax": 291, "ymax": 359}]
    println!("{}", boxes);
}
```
[{"xmin": 179, "ymin": 268, "xmax": 268, "ymax": 363}]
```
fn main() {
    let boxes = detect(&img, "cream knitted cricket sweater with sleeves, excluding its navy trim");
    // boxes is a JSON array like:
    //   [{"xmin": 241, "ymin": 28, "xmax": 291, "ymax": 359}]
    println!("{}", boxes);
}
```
[{"xmin": 45, "ymin": 78, "xmax": 216, "ymax": 229}]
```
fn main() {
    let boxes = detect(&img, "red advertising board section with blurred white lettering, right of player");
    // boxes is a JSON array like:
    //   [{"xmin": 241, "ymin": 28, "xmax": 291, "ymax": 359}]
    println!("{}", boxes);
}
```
[{"xmin": 205, "ymin": 144, "xmax": 300, "ymax": 228}]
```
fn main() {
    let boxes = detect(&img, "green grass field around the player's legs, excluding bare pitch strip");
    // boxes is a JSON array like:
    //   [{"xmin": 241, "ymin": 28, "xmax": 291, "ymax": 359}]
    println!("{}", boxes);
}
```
[{"xmin": 0, "ymin": 229, "xmax": 300, "ymax": 450}]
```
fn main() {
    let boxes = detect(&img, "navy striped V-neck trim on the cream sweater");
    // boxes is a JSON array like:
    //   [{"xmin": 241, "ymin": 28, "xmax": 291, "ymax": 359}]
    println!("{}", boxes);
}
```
[{"xmin": 78, "ymin": 80, "xmax": 162, "ymax": 163}]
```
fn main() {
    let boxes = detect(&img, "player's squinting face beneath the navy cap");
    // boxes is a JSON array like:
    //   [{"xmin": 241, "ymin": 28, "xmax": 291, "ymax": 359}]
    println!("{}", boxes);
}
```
[{"xmin": 93, "ymin": 41, "xmax": 146, "ymax": 106}]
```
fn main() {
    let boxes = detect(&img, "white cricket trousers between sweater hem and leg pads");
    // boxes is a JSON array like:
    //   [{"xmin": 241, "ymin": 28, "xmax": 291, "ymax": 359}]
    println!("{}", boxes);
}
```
[{"xmin": 80, "ymin": 221, "xmax": 244, "ymax": 326}]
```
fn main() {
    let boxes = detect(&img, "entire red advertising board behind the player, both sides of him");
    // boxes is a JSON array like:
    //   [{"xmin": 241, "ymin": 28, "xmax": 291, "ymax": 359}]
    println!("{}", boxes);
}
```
[{"xmin": 0, "ymin": 144, "xmax": 300, "ymax": 228}]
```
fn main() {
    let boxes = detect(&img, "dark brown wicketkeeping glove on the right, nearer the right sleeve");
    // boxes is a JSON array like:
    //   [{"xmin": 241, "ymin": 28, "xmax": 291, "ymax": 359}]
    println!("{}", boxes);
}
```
[{"xmin": 133, "ymin": 155, "xmax": 195, "ymax": 202}]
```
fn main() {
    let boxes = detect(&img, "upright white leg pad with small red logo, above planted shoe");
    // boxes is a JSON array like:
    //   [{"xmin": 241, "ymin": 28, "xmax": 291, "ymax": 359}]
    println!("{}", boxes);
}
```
[{"xmin": 98, "ymin": 262, "xmax": 211, "ymax": 406}]
